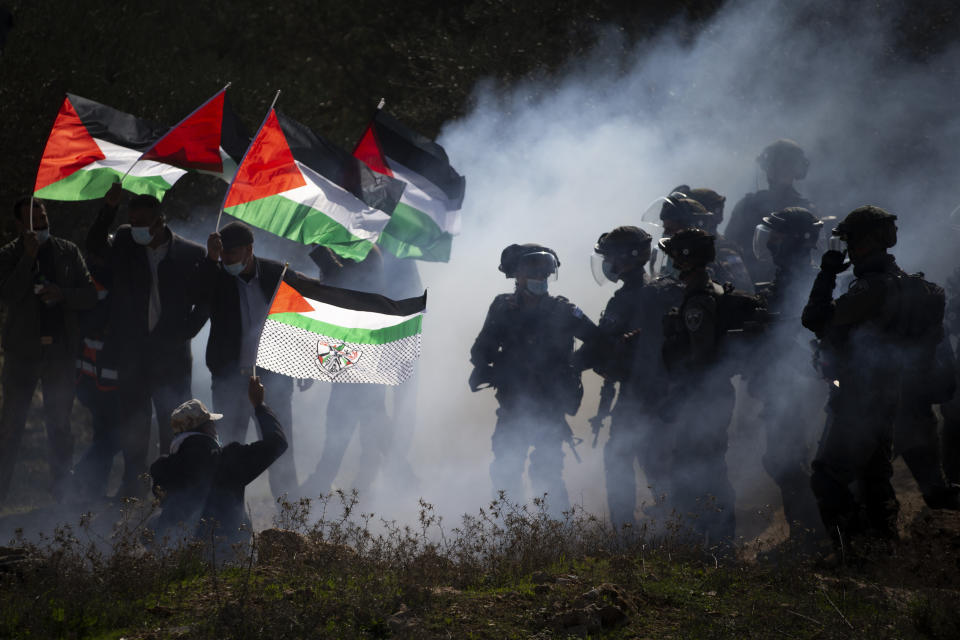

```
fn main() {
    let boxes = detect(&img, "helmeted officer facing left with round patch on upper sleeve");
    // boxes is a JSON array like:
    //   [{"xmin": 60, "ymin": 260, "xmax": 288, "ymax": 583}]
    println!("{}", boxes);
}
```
[{"xmin": 659, "ymin": 229, "xmax": 735, "ymax": 543}]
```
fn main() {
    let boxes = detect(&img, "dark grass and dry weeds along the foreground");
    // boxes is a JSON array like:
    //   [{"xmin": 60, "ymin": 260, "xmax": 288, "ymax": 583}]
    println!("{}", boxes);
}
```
[{"xmin": 0, "ymin": 493, "xmax": 960, "ymax": 639}]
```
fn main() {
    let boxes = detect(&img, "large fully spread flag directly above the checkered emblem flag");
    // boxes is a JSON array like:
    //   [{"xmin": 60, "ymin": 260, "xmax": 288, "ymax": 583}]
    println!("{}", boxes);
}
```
[{"xmin": 223, "ymin": 109, "xmax": 404, "ymax": 260}]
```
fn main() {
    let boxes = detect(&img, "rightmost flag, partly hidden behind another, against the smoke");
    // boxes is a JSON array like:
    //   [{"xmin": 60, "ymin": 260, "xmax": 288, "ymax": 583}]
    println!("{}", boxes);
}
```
[{"xmin": 353, "ymin": 110, "xmax": 465, "ymax": 262}]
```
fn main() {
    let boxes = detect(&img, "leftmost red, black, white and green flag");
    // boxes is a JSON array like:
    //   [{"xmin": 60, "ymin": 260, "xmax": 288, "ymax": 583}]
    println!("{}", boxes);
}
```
[{"xmin": 33, "ymin": 93, "xmax": 186, "ymax": 200}]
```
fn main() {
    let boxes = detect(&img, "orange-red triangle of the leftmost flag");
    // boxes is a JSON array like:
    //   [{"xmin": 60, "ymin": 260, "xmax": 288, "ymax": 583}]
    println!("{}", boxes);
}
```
[{"xmin": 33, "ymin": 98, "xmax": 106, "ymax": 192}]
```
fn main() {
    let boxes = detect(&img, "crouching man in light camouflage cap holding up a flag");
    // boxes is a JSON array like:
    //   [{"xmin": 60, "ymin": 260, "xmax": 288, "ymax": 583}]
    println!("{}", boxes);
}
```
[{"xmin": 150, "ymin": 377, "xmax": 287, "ymax": 541}]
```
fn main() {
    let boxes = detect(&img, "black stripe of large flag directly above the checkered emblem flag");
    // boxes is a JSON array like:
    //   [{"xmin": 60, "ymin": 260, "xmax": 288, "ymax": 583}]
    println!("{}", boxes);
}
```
[{"xmin": 277, "ymin": 111, "xmax": 406, "ymax": 214}]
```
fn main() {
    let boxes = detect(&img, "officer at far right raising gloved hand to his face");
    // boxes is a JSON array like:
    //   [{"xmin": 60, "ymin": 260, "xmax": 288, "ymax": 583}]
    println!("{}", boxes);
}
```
[{"xmin": 802, "ymin": 205, "xmax": 944, "ymax": 548}]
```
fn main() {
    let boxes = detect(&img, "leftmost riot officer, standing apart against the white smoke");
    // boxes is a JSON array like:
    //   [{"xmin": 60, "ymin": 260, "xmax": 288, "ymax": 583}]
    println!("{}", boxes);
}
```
[{"xmin": 470, "ymin": 244, "xmax": 596, "ymax": 515}]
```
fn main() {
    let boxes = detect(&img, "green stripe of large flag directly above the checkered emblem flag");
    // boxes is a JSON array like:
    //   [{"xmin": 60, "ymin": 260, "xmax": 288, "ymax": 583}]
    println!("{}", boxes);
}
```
[{"xmin": 224, "ymin": 195, "xmax": 373, "ymax": 261}]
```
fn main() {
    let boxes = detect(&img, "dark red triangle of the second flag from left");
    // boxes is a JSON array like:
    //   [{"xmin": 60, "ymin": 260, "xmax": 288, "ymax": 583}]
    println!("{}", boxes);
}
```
[{"xmin": 141, "ymin": 90, "xmax": 226, "ymax": 172}]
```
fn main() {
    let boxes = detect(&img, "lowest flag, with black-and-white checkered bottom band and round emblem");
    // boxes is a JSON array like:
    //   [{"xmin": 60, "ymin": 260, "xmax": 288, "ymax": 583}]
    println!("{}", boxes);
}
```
[{"xmin": 257, "ymin": 280, "xmax": 427, "ymax": 384}]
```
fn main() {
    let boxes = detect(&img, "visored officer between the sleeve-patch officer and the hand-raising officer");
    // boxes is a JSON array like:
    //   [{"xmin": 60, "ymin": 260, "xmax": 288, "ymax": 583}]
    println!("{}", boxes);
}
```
[{"xmin": 748, "ymin": 207, "xmax": 827, "ymax": 542}]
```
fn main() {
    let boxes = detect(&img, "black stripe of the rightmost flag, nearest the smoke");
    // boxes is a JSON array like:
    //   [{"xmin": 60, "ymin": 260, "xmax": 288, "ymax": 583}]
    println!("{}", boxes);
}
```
[{"xmin": 373, "ymin": 110, "xmax": 466, "ymax": 209}]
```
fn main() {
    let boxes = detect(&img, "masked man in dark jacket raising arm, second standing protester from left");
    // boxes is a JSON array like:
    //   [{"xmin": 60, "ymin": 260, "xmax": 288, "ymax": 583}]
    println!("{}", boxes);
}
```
[{"xmin": 87, "ymin": 184, "xmax": 208, "ymax": 495}]
